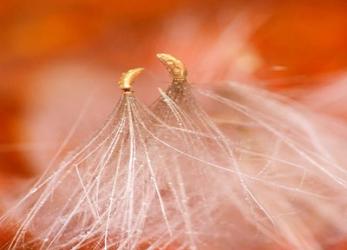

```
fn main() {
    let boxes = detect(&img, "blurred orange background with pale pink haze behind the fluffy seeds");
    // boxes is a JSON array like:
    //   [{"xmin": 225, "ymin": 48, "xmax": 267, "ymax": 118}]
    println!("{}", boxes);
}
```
[{"xmin": 0, "ymin": 0, "xmax": 347, "ymax": 247}]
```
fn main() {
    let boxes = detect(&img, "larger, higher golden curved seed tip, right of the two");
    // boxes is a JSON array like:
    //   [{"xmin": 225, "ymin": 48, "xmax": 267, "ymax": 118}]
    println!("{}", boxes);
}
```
[{"xmin": 157, "ymin": 53, "xmax": 187, "ymax": 83}]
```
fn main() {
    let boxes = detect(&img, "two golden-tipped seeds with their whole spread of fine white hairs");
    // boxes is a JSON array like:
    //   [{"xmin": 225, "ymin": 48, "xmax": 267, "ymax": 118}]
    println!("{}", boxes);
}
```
[{"xmin": 0, "ymin": 54, "xmax": 347, "ymax": 250}]
